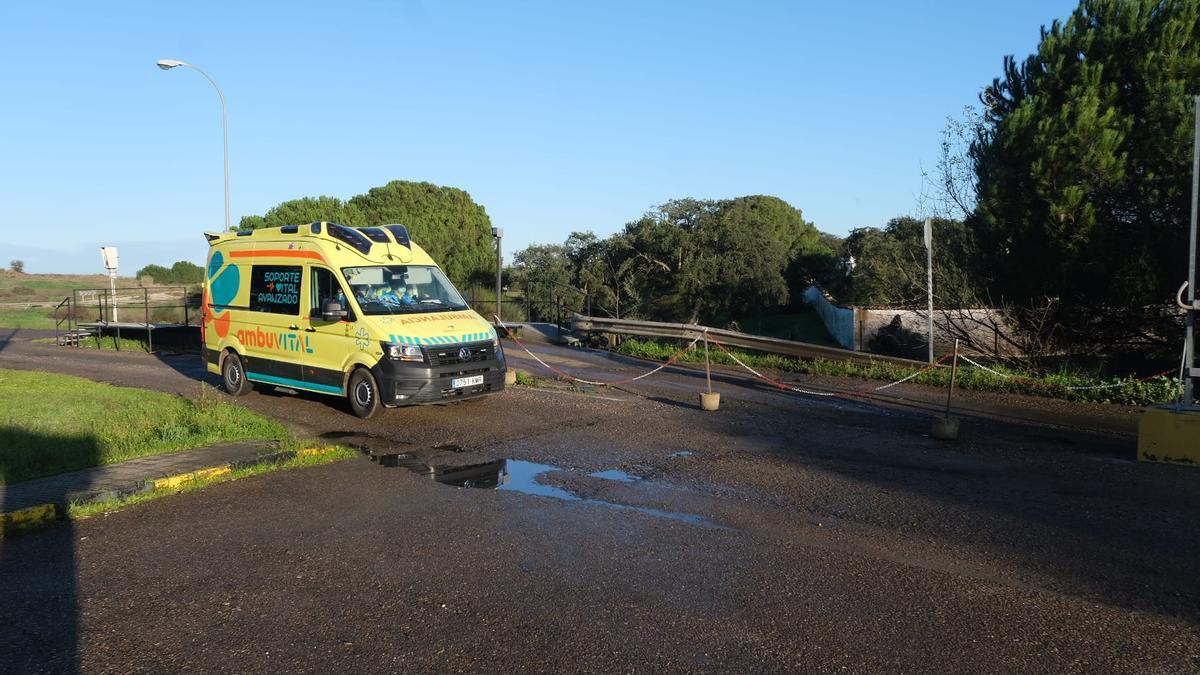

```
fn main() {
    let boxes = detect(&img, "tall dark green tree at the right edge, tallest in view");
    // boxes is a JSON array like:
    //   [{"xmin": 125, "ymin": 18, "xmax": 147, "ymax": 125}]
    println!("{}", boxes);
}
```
[{"xmin": 970, "ymin": 0, "xmax": 1200, "ymax": 347}]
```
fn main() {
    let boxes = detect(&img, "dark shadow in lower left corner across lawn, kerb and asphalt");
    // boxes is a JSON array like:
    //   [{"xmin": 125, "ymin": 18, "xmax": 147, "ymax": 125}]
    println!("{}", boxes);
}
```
[{"xmin": 0, "ymin": 426, "xmax": 100, "ymax": 673}]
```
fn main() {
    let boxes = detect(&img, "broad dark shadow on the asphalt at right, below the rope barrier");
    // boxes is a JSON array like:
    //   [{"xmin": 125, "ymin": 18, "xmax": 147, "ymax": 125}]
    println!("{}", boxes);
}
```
[{"xmin": 681, "ymin": 401, "xmax": 1200, "ymax": 623}]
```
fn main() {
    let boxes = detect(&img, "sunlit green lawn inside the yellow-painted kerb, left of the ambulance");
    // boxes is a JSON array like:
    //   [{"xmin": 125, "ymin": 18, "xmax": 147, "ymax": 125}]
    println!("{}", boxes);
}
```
[{"xmin": 0, "ymin": 369, "xmax": 287, "ymax": 484}]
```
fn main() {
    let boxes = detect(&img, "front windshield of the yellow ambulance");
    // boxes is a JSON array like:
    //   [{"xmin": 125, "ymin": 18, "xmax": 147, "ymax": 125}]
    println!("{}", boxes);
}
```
[{"xmin": 342, "ymin": 265, "xmax": 467, "ymax": 316}]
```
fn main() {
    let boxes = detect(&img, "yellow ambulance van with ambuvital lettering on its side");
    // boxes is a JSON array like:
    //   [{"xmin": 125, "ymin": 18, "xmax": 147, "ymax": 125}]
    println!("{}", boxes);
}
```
[{"xmin": 200, "ymin": 222, "xmax": 505, "ymax": 418}]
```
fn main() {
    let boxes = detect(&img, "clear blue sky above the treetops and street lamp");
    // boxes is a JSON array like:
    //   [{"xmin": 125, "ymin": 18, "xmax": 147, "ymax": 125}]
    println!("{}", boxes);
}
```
[{"xmin": 0, "ymin": 0, "xmax": 1075, "ymax": 273}]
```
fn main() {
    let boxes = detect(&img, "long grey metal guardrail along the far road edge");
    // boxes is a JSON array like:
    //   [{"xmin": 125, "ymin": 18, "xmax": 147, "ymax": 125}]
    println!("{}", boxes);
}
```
[{"xmin": 571, "ymin": 313, "xmax": 929, "ymax": 368}]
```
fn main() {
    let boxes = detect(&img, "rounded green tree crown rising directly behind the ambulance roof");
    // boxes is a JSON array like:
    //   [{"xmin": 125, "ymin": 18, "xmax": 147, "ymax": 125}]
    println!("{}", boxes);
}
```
[{"xmin": 241, "ymin": 180, "xmax": 496, "ymax": 286}]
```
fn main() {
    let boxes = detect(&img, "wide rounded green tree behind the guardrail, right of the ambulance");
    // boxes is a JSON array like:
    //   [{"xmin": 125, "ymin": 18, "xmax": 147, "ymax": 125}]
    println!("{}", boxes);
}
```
[{"xmin": 515, "ymin": 196, "xmax": 832, "ymax": 323}]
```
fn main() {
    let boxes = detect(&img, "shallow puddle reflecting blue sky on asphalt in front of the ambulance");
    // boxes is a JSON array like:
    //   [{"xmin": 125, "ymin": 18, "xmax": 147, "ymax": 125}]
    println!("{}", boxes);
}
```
[{"xmin": 378, "ymin": 453, "xmax": 730, "ymax": 530}]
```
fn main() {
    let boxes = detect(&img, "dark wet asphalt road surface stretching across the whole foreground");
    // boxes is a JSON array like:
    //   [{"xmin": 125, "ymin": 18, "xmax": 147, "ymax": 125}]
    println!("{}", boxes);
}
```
[{"xmin": 0, "ymin": 335, "xmax": 1200, "ymax": 673}]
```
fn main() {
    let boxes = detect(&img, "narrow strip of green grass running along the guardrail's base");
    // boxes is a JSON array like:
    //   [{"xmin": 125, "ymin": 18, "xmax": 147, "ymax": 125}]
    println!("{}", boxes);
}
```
[{"xmin": 617, "ymin": 339, "xmax": 1178, "ymax": 406}]
